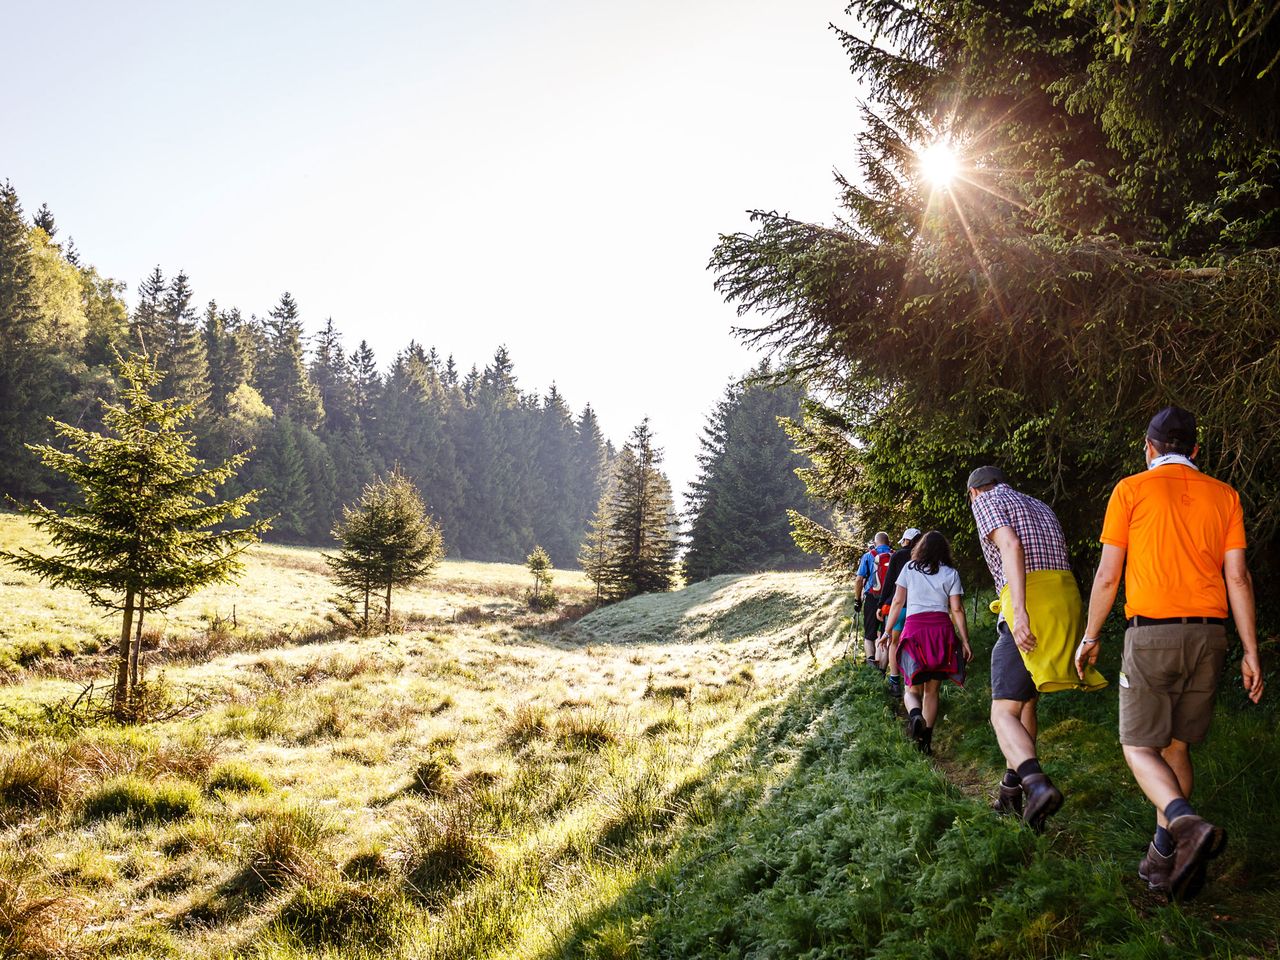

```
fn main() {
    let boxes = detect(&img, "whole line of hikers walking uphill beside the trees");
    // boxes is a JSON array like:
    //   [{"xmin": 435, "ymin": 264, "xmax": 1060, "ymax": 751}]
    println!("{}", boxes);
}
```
[{"xmin": 855, "ymin": 407, "xmax": 1263, "ymax": 900}]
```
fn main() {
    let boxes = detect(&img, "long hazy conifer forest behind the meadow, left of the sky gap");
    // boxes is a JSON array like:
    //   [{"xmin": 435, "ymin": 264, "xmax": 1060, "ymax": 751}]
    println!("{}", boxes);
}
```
[{"xmin": 0, "ymin": 186, "xmax": 613, "ymax": 564}]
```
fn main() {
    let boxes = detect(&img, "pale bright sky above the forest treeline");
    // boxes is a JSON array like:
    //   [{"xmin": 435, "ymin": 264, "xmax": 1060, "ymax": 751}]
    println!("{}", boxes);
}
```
[{"xmin": 0, "ymin": 0, "xmax": 859, "ymax": 506}]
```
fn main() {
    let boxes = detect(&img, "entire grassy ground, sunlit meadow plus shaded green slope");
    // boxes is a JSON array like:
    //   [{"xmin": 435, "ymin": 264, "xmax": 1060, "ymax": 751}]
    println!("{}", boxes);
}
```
[{"xmin": 0, "ymin": 517, "xmax": 1280, "ymax": 960}]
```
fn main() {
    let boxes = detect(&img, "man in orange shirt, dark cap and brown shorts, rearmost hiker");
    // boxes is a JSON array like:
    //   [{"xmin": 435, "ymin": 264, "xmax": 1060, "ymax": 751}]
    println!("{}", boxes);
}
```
[{"xmin": 1075, "ymin": 407, "xmax": 1262, "ymax": 900}]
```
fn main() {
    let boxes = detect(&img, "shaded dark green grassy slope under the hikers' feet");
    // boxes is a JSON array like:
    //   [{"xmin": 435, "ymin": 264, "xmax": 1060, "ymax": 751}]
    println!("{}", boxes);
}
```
[{"xmin": 547, "ymin": 636, "xmax": 1280, "ymax": 959}]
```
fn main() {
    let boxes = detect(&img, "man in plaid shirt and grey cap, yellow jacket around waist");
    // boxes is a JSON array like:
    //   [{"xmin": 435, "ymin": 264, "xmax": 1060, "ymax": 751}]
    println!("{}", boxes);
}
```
[{"xmin": 968, "ymin": 466, "xmax": 1082, "ymax": 831}]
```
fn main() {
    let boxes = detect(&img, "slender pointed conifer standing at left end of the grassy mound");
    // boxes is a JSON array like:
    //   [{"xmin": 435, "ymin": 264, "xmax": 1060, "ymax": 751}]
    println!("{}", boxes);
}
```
[{"xmin": 603, "ymin": 419, "xmax": 676, "ymax": 599}]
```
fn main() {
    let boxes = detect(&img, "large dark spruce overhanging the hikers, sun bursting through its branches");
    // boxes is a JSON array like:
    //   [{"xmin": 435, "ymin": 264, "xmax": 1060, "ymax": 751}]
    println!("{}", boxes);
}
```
[{"xmin": 712, "ymin": 0, "xmax": 1280, "ymax": 599}]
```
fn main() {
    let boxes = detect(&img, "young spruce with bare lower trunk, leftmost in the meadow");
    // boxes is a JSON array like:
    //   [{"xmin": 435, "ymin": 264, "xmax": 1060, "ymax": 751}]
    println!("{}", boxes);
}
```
[{"xmin": 0, "ymin": 357, "xmax": 266, "ymax": 719}]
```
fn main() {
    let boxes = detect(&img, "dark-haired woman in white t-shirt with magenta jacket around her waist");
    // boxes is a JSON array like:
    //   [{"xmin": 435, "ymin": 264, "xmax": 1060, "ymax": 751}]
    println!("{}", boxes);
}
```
[{"xmin": 884, "ymin": 530, "xmax": 973, "ymax": 754}]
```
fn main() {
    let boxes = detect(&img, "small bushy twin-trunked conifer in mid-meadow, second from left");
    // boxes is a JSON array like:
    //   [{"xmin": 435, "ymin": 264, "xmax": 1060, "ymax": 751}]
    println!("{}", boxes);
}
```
[{"xmin": 325, "ymin": 471, "xmax": 444, "ymax": 632}]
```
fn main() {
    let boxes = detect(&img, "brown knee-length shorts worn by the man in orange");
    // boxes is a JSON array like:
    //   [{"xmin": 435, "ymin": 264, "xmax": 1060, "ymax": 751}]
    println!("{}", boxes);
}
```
[{"xmin": 1120, "ymin": 623, "xmax": 1226, "ymax": 748}]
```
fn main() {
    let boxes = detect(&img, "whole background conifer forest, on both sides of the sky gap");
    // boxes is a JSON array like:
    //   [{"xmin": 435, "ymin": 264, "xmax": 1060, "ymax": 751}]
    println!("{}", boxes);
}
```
[{"xmin": 0, "ymin": 183, "xmax": 806, "ymax": 578}]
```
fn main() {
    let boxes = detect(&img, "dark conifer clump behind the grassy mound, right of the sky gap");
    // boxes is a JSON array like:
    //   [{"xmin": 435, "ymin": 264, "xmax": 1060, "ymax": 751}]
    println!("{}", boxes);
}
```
[{"xmin": 684, "ymin": 361, "xmax": 815, "ymax": 581}]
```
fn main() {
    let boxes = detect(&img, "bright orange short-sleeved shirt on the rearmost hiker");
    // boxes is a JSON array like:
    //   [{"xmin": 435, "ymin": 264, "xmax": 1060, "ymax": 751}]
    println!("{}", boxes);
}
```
[{"xmin": 1102, "ymin": 463, "xmax": 1244, "ymax": 617}]
